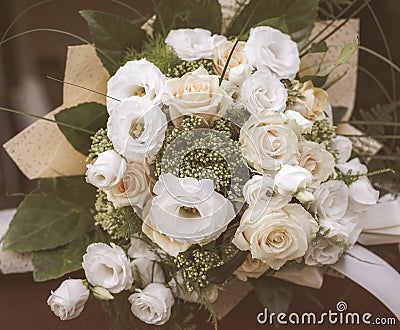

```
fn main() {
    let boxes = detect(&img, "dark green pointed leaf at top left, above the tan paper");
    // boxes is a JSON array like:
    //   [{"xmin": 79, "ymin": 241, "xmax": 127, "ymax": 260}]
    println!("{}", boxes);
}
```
[{"xmin": 79, "ymin": 10, "xmax": 146, "ymax": 74}]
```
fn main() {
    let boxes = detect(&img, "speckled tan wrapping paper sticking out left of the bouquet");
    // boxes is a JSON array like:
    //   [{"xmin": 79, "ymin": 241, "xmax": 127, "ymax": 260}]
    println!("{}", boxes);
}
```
[{"xmin": 4, "ymin": 45, "xmax": 109, "ymax": 179}]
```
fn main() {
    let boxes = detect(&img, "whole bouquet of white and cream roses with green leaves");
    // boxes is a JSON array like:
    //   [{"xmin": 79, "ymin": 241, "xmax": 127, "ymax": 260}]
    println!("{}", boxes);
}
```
[{"xmin": 0, "ymin": 0, "xmax": 400, "ymax": 325}]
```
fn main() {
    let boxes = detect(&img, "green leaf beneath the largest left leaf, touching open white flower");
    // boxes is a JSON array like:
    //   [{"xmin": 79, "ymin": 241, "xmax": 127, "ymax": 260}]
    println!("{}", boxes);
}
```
[{"xmin": 32, "ymin": 237, "xmax": 91, "ymax": 282}]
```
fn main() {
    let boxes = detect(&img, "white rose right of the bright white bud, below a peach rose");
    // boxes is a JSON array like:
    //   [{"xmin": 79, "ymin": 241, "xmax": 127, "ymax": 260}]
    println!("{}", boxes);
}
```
[{"xmin": 309, "ymin": 180, "xmax": 349, "ymax": 219}]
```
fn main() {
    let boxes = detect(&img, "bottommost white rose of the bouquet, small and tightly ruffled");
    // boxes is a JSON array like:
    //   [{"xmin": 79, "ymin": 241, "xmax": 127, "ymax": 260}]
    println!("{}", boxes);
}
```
[{"xmin": 128, "ymin": 283, "xmax": 174, "ymax": 325}]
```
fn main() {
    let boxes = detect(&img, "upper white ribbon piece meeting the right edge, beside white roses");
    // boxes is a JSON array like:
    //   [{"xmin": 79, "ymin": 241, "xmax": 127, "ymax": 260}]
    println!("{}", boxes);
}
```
[{"xmin": 358, "ymin": 199, "xmax": 400, "ymax": 245}]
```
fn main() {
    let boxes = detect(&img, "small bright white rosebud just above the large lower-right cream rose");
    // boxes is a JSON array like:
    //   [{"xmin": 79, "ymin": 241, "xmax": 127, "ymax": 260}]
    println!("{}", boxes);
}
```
[{"xmin": 275, "ymin": 165, "xmax": 312, "ymax": 195}]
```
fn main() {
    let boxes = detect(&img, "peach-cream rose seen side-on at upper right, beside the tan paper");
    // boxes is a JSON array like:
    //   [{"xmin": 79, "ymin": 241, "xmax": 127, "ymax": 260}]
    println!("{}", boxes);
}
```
[{"xmin": 289, "ymin": 80, "xmax": 329, "ymax": 121}]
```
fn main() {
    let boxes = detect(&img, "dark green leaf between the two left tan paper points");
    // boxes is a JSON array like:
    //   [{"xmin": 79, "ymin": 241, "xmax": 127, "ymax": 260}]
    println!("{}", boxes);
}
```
[{"xmin": 55, "ymin": 102, "xmax": 108, "ymax": 155}]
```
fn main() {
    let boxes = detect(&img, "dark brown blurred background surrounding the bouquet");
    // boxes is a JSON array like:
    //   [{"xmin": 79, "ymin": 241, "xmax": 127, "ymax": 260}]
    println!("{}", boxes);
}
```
[{"xmin": 0, "ymin": 0, "xmax": 400, "ymax": 329}]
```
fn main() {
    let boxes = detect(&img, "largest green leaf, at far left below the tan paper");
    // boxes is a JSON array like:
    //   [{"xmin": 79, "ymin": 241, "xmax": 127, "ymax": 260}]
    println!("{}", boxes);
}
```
[{"xmin": 3, "ymin": 176, "xmax": 96, "ymax": 252}]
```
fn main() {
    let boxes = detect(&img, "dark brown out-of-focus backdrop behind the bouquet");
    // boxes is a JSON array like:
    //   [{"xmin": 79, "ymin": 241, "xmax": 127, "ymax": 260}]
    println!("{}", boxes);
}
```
[{"xmin": 0, "ymin": 0, "xmax": 400, "ymax": 330}]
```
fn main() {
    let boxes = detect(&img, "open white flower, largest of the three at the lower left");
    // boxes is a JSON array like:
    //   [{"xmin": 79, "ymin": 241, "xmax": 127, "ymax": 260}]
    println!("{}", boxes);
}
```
[{"xmin": 82, "ymin": 243, "xmax": 133, "ymax": 293}]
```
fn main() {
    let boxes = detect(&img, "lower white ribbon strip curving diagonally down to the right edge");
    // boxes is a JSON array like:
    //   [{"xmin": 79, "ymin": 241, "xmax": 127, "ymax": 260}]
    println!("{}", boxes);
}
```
[{"xmin": 330, "ymin": 244, "xmax": 400, "ymax": 320}]
